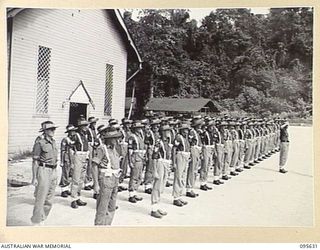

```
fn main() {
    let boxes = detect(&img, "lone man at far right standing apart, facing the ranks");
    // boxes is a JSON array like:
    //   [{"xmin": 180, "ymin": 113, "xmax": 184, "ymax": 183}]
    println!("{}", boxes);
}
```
[{"xmin": 279, "ymin": 120, "xmax": 289, "ymax": 174}]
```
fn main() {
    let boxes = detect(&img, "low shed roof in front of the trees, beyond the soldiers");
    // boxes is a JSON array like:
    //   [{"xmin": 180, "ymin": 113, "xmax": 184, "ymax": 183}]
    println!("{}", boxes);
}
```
[{"xmin": 145, "ymin": 97, "xmax": 221, "ymax": 112}]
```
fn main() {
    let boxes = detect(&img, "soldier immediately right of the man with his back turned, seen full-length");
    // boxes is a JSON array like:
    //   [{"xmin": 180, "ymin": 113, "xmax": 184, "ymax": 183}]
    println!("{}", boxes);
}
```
[{"xmin": 128, "ymin": 121, "xmax": 146, "ymax": 203}]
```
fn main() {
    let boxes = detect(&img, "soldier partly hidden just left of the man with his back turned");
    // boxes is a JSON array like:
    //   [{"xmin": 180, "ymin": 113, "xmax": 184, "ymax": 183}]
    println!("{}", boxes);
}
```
[{"xmin": 84, "ymin": 116, "xmax": 99, "ymax": 193}]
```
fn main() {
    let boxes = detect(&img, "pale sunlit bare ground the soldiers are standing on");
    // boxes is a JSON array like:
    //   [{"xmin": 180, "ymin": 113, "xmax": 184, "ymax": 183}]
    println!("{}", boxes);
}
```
[{"xmin": 7, "ymin": 127, "xmax": 314, "ymax": 227}]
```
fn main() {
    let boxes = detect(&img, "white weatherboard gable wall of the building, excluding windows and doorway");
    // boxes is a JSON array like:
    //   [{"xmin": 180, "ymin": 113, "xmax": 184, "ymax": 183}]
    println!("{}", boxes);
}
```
[{"xmin": 9, "ymin": 9, "xmax": 127, "ymax": 153}]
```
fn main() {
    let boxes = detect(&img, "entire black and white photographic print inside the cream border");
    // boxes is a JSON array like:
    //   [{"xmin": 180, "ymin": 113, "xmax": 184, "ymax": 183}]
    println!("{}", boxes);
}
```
[{"xmin": 3, "ymin": 6, "xmax": 315, "ymax": 228}]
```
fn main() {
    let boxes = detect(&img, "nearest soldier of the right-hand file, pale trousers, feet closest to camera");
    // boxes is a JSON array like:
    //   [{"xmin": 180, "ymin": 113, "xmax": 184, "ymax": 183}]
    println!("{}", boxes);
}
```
[{"xmin": 151, "ymin": 124, "xmax": 172, "ymax": 218}]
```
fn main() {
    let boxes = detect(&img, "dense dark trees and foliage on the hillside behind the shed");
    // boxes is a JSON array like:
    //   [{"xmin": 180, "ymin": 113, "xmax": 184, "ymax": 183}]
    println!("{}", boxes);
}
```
[{"xmin": 124, "ymin": 8, "xmax": 313, "ymax": 117}]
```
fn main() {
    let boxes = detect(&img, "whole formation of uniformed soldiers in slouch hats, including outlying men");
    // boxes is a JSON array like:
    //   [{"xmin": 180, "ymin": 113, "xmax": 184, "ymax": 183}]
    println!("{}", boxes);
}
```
[{"xmin": 31, "ymin": 115, "xmax": 289, "ymax": 225}]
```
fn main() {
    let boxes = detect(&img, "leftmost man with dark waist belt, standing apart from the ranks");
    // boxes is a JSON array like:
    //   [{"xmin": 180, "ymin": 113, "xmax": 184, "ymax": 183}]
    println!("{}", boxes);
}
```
[{"xmin": 31, "ymin": 121, "xmax": 58, "ymax": 225}]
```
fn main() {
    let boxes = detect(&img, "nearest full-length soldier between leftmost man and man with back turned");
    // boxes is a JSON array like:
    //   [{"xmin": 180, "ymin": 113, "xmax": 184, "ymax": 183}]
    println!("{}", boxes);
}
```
[{"xmin": 71, "ymin": 119, "xmax": 89, "ymax": 208}]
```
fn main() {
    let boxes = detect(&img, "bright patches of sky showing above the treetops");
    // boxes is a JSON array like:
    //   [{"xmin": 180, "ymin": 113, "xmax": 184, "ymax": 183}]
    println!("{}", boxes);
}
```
[{"xmin": 121, "ymin": 7, "xmax": 269, "ymax": 23}]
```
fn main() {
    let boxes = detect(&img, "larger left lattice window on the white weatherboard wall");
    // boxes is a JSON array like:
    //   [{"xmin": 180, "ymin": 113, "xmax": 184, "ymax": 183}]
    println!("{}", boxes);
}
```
[{"xmin": 36, "ymin": 46, "xmax": 51, "ymax": 114}]
